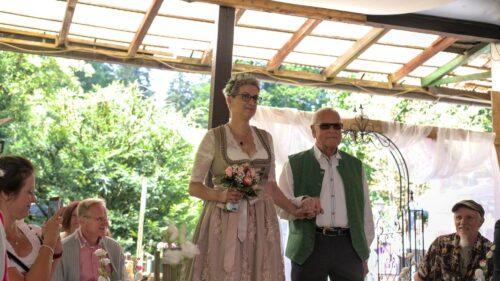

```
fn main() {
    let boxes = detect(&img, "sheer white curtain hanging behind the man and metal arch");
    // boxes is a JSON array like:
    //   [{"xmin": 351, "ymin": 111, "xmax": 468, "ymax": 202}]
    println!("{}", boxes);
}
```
[{"xmin": 252, "ymin": 106, "xmax": 500, "ymax": 280}]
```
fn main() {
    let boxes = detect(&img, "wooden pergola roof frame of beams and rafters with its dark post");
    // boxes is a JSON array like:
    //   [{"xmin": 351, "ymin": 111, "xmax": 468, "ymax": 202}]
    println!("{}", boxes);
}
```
[{"xmin": 0, "ymin": 0, "xmax": 500, "ymax": 158}]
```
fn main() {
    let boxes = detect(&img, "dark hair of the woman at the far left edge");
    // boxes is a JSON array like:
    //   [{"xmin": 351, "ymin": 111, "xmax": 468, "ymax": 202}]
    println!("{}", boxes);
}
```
[{"xmin": 0, "ymin": 156, "xmax": 35, "ymax": 195}]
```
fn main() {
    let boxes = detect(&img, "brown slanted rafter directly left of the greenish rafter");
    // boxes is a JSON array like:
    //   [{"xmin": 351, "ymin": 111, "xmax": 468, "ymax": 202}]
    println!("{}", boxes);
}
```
[{"xmin": 390, "ymin": 37, "xmax": 457, "ymax": 83}]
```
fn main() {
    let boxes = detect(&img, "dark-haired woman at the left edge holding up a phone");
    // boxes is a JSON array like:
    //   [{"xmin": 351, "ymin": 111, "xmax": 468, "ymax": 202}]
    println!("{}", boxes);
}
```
[{"xmin": 0, "ymin": 156, "xmax": 64, "ymax": 281}]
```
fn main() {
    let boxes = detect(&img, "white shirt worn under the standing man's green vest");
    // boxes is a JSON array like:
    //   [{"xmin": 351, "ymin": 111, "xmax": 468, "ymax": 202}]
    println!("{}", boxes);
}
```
[{"xmin": 278, "ymin": 145, "xmax": 375, "ymax": 247}]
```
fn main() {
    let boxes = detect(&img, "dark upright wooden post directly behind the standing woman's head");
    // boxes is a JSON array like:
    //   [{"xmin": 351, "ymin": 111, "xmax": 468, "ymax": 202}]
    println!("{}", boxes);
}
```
[{"xmin": 208, "ymin": 6, "xmax": 235, "ymax": 128}]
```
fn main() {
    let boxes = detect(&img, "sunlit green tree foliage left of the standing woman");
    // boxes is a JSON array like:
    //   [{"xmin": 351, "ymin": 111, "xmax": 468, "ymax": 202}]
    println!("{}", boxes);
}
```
[{"xmin": 0, "ymin": 50, "xmax": 200, "ymax": 250}]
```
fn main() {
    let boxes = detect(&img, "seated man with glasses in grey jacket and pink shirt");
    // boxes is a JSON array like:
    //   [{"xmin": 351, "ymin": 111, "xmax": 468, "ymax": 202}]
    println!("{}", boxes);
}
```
[{"xmin": 54, "ymin": 198, "xmax": 125, "ymax": 281}]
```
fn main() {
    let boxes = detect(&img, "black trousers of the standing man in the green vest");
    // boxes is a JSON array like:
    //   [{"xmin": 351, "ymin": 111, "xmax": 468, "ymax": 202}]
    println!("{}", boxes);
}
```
[{"xmin": 291, "ymin": 233, "xmax": 364, "ymax": 281}]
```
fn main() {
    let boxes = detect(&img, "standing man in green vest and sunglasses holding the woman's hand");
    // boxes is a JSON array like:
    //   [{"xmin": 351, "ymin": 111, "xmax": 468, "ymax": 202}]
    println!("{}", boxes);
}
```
[{"xmin": 279, "ymin": 108, "xmax": 374, "ymax": 281}]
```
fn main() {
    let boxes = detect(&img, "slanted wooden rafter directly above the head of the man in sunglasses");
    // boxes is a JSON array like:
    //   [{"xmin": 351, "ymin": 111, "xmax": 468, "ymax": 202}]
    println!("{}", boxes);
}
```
[{"xmin": 323, "ymin": 28, "xmax": 389, "ymax": 79}]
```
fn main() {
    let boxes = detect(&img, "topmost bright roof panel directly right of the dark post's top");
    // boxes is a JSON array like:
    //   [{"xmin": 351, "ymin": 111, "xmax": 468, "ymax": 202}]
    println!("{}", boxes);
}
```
[{"xmin": 238, "ymin": 10, "xmax": 307, "ymax": 32}]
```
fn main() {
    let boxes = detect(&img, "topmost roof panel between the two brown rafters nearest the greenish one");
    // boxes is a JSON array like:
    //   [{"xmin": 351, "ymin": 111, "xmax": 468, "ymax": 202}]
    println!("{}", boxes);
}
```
[{"xmin": 378, "ymin": 29, "xmax": 439, "ymax": 48}]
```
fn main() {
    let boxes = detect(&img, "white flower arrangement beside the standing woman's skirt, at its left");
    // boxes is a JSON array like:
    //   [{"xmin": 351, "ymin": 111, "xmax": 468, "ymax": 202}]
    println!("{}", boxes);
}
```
[{"xmin": 157, "ymin": 224, "xmax": 200, "ymax": 265}]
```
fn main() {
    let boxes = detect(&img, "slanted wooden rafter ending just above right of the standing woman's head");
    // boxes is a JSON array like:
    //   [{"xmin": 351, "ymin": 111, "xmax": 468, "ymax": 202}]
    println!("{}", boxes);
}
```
[{"xmin": 267, "ymin": 19, "xmax": 321, "ymax": 71}]
